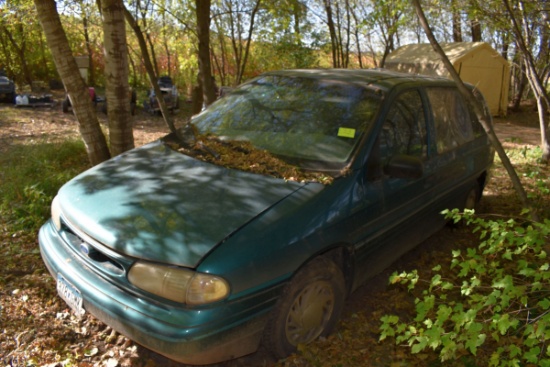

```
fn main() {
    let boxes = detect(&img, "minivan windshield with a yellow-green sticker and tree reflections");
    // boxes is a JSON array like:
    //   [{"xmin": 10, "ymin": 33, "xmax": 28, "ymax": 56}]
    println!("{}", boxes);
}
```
[{"xmin": 192, "ymin": 75, "xmax": 380, "ymax": 171}]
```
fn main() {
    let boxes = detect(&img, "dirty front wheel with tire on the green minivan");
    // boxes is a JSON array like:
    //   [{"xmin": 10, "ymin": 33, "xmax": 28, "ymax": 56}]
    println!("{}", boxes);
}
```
[{"xmin": 264, "ymin": 257, "xmax": 346, "ymax": 359}]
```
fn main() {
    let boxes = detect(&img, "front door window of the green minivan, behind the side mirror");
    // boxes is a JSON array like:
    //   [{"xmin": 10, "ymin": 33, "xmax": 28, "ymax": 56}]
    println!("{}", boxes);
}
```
[{"xmin": 380, "ymin": 90, "xmax": 428, "ymax": 163}]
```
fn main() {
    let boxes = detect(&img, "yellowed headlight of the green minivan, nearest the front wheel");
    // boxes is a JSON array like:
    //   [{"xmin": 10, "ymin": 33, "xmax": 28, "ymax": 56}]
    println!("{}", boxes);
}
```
[{"xmin": 128, "ymin": 262, "xmax": 229, "ymax": 305}]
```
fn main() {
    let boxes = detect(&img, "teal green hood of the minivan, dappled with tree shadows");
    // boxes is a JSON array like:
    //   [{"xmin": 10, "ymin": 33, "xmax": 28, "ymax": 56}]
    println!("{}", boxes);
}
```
[{"xmin": 58, "ymin": 141, "xmax": 305, "ymax": 267}]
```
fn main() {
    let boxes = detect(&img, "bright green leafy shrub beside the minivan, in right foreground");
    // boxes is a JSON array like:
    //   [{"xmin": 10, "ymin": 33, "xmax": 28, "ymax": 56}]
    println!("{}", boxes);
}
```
[{"xmin": 380, "ymin": 210, "xmax": 550, "ymax": 366}]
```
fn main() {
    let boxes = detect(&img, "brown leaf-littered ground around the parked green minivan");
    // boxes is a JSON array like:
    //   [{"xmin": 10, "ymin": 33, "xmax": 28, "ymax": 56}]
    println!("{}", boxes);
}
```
[{"xmin": 0, "ymin": 99, "xmax": 550, "ymax": 367}]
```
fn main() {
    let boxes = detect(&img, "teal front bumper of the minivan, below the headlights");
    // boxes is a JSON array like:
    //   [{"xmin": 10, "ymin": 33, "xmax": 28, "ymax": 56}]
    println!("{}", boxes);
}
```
[{"xmin": 38, "ymin": 222, "xmax": 278, "ymax": 365}]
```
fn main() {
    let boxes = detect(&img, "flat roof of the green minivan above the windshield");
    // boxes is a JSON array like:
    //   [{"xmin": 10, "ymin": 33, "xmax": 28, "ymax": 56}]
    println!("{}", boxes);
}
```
[{"xmin": 263, "ymin": 68, "xmax": 454, "ymax": 91}]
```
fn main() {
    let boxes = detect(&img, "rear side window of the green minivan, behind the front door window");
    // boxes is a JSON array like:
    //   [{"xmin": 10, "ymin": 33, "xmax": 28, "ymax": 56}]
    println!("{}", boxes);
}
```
[{"xmin": 427, "ymin": 88, "xmax": 474, "ymax": 153}]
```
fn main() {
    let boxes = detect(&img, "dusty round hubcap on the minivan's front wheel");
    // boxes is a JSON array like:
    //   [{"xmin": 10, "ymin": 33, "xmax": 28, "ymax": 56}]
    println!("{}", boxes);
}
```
[{"xmin": 285, "ymin": 281, "xmax": 334, "ymax": 346}]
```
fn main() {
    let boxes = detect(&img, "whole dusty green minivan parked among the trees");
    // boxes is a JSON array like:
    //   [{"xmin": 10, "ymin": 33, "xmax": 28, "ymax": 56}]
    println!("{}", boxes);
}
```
[{"xmin": 39, "ymin": 70, "xmax": 493, "ymax": 364}]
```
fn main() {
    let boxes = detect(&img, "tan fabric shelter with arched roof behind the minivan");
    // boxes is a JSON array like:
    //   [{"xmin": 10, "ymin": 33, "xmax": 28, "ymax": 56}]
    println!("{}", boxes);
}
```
[{"xmin": 384, "ymin": 42, "xmax": 510, "ymax": 116}]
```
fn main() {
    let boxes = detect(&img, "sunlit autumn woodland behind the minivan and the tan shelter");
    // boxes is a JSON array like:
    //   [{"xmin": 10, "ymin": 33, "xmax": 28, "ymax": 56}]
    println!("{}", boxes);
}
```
[{"xmin": 0, "ymin": 0, "xmax": 550, "ymax": 108}]
